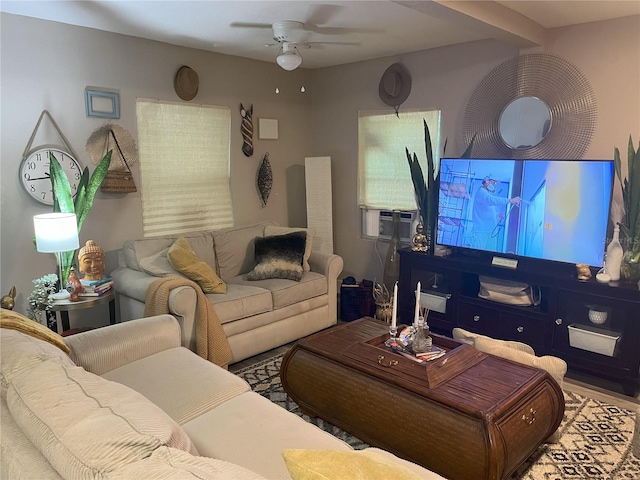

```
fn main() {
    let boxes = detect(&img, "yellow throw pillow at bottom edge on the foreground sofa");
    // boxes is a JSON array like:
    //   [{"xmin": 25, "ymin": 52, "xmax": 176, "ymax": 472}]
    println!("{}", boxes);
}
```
[{"xmin": 282, "ymin": 449, "xmax": 421, "ymax": 480}]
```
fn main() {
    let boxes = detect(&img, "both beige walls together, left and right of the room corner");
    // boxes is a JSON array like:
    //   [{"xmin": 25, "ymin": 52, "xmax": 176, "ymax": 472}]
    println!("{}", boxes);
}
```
[{"xmin": 0, "ymin": 14, "xmax": 640, "ymax": 326}]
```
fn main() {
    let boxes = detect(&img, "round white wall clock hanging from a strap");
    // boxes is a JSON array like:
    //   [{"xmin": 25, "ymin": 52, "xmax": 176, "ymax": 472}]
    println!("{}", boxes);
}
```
[{"xmin": 19, "ymin": 146, "xmax": 82, "ymax": 205}]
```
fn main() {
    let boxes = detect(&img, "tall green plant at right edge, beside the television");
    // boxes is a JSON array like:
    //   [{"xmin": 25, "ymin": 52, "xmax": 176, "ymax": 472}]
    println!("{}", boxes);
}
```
[{"xmin": 613, "ymin": 135, "xmax": 640, "ymax": 255}]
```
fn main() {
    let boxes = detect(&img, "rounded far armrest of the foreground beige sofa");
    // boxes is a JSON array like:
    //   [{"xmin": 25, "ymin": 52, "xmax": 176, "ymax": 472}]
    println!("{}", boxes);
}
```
[{"xmin": 65, "ymin": 315, "xmax": 181, "ymax": 375}]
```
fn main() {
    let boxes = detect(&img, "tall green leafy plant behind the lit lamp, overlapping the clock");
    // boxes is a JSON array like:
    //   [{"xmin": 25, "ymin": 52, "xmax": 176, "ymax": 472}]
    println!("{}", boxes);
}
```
[{"xmin": 49, "ymin": 150, "xmax": 112, "ymax": 285}]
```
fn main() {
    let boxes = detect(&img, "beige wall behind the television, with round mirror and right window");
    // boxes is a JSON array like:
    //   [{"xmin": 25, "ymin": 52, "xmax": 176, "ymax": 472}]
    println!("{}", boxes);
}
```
[{"xmin": 312, "ymin": 16, "xmax": 640, "ymax": 281}]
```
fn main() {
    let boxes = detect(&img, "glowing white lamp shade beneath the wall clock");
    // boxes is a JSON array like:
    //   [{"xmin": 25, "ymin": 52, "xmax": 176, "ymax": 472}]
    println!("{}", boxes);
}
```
[{"xmin": 33, "ymin": 213, "xmax": 80, "ymax": 253}]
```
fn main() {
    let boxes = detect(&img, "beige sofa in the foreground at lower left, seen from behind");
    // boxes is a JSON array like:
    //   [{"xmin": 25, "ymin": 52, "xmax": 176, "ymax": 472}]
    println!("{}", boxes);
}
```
[{"xmin": 0, "ymin": 315, "xmax": 441, "ymax": 480}]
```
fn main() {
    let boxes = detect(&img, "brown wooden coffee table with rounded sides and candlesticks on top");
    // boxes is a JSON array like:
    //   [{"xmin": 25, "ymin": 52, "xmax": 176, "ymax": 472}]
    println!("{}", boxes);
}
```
[{"xmin": 280, "ymin": 317, "xmax": 564, "ymax": 480}]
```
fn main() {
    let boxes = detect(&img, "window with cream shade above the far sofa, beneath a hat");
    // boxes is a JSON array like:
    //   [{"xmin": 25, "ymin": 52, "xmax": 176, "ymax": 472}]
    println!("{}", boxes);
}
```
[{"xmin": 136, "ymin": 99, "xmax": 233, "ymax": 237}]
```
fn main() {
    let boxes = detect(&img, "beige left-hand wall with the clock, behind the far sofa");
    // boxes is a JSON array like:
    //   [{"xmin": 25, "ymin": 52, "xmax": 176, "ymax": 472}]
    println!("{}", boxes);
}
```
[{"xmin": 0, "ymin": 13, "xmax": 310, "ymax": 326}]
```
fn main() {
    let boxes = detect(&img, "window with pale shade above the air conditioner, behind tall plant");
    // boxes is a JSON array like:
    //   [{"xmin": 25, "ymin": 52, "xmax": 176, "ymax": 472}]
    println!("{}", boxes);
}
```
[{"xmin": 358, "ymin": 110, "xmax": 440, "ymax": 237}]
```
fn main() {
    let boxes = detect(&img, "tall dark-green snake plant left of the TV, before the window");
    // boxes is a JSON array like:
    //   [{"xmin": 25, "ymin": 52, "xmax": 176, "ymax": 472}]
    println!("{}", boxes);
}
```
[{"xmin": 405, "ymin": 119, "xmax": 476, "ymax": 253}]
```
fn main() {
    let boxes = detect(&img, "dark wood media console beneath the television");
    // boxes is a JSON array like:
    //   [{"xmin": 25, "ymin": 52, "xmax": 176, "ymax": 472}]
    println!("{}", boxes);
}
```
[{"xmin": 398, "ymin": 249, "xmax": 640, "ymax": 396}]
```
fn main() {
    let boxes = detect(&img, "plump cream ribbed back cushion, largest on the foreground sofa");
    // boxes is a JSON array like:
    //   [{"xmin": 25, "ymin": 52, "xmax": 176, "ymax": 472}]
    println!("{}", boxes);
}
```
[{"xmin": 7, "ymin": 358, "xmax": 198, "ymax": 478}]
